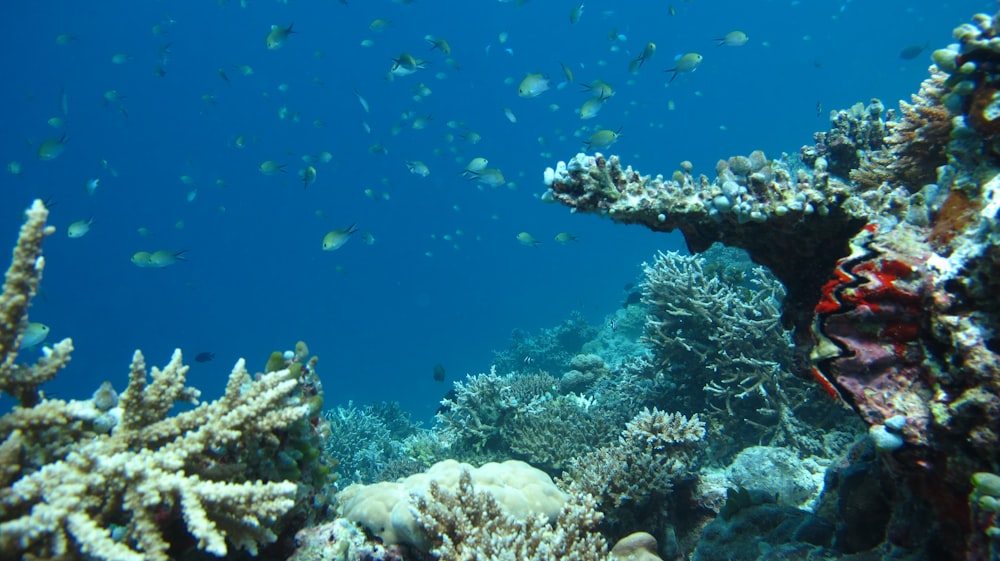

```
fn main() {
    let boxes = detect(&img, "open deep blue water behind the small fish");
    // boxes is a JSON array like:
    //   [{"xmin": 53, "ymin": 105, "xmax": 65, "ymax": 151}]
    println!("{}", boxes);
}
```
[{"xmin": 0, "ymin": 0, "xmax": 984, "ymax": 418}]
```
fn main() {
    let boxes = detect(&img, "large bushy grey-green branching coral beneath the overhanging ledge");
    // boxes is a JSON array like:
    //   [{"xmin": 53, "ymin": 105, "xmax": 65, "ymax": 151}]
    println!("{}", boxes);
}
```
[{"xmin": 640, "ymin": 246, "xmax": 856, "ymax": 461}]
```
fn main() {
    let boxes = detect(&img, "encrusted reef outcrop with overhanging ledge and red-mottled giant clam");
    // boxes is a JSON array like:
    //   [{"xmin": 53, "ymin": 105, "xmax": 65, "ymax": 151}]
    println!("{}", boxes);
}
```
[{"xmin": 546, "ymin": 9, "xmax": 1000, "ymax": 559}]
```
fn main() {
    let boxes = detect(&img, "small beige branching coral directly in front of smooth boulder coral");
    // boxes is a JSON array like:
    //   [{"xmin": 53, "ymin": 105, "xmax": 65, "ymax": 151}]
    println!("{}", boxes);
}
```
[{"xmin": 411, "ymin": 464, "xmax": 608, "ymax": 561}]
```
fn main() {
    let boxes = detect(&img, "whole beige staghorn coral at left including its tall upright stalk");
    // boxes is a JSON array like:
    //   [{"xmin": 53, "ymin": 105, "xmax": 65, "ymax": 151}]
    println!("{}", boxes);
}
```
[{"xmin": 0, "ymin": 201, "xmax": 309, "ymax": 561}]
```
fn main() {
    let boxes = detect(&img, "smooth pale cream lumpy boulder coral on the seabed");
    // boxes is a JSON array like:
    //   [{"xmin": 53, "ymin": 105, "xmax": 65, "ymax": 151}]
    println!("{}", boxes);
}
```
[{"xmin": 338, "ymin": 460, "xmax": 568, "ymax": 551}]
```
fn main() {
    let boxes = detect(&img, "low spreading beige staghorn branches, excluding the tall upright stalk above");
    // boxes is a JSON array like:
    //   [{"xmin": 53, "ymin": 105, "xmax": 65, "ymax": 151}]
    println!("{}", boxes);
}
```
[{"xmin": 0, "ymin": 351, "xmax": 307, "ymax": 561}]
